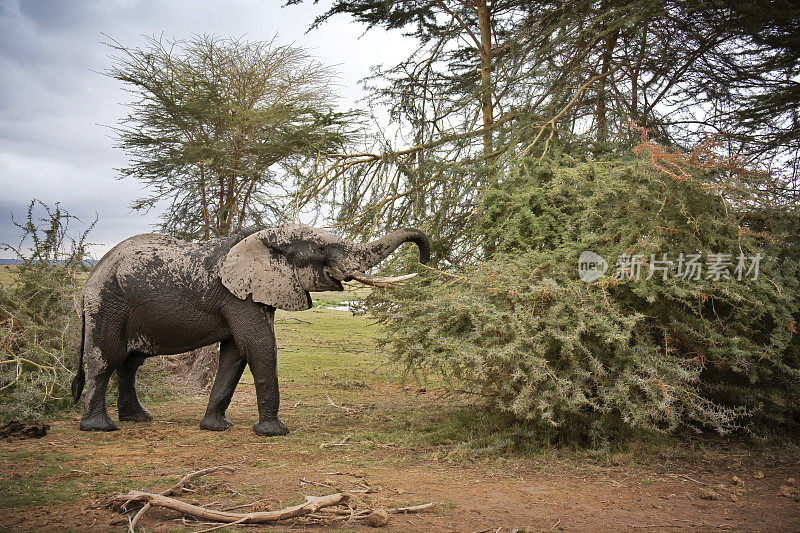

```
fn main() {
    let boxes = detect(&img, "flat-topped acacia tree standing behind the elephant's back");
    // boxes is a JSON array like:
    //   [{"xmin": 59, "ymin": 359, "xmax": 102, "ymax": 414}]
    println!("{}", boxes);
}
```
[{"xmin": 106, "ymin": 35, "xmax": 348, "ymax": 239}]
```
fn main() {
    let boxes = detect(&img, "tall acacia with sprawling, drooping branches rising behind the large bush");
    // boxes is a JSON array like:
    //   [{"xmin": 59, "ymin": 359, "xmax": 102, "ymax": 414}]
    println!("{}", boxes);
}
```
[{"xmin": 289, "ymin": 0, "xmax": 800, "ymax": 265}]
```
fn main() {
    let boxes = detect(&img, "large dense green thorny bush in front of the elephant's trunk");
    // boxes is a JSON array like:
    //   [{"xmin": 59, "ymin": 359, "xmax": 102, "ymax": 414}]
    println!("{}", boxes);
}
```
[{"xmin": 371, "ymin": 145, "xmax": 800, "ymax": 443}]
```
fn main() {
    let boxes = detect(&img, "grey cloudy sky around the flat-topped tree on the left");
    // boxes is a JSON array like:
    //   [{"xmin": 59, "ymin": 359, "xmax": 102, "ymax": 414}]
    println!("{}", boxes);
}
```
[{"xmin": 0, "ymin": 0, "xmax": 412, "ymax": 257}]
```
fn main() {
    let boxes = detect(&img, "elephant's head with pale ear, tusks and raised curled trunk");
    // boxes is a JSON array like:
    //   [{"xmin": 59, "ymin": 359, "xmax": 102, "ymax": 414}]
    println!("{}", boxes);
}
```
[{"xmin": 220, "ymin": 224, "xmax": 430, "ymax": 311}]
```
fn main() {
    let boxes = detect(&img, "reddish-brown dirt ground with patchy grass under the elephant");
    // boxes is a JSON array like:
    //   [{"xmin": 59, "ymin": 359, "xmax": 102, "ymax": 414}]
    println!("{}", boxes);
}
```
[{"xmin": 0, "ymin": 310, "xmax": 800, "ymax": 532}]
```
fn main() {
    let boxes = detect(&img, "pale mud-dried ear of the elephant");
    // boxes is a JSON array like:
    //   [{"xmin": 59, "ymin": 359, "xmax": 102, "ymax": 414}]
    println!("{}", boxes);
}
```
[{"xmin": 220, "ymin": 229, "xmax": 311, "ymax": 311}]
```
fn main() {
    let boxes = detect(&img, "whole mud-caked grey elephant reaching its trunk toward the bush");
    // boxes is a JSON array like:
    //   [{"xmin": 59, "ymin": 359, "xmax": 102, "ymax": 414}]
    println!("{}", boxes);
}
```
[{"xmin": 72, "ymin": 224, "xmax": 430, "ymax": 436}]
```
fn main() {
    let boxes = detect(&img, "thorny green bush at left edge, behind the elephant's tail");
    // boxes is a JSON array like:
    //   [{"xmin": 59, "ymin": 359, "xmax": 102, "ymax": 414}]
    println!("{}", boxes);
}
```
[{"xmin": 0, "ymin": 200, "xmax": 94, "ymax": 419}]
